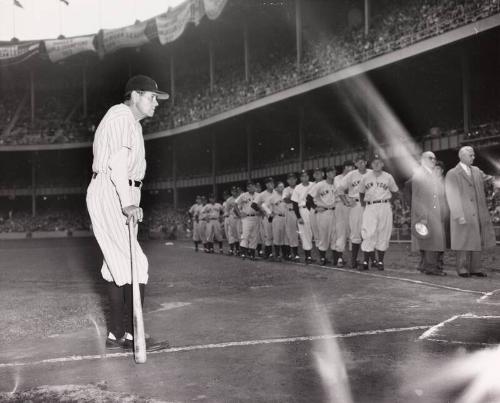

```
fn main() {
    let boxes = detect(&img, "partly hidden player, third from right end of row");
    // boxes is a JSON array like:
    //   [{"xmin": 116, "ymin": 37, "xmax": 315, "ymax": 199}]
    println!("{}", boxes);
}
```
[{"xmin": 333, "ymin": 161, "xmax": 354, "ymax": 267}]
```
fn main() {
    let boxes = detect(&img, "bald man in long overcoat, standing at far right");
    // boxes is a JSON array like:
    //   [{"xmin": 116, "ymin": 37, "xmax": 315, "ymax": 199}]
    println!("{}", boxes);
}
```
[{"xmin": 445, "ymin": 146, "xmax": 496, "ymax": 277}]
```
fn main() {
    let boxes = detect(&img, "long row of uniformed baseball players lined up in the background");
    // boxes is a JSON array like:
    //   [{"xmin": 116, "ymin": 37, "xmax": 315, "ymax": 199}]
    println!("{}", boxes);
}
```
[{"xmin": 189, "ymin": 155, "xmax": 398, "ymax": 270}]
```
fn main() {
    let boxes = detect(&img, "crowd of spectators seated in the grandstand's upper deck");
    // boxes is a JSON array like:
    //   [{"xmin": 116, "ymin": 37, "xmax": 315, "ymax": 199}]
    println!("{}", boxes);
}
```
[{"xmin": 0, "ymin": 0, "xmax": 500, "ymax": 145}]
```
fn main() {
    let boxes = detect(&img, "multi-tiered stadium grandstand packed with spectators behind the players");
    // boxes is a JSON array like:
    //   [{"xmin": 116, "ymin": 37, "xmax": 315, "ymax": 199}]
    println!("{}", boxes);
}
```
[{"xmin": 0, "ymin": 0, "xmax": 500, "ymax": 240}]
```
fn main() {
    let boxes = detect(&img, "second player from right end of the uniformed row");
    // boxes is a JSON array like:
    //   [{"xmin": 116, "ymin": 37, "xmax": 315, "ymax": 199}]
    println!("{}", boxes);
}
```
[{"xmin": 341, "ymin": 155, "xmax": 371, "ymax": 269}]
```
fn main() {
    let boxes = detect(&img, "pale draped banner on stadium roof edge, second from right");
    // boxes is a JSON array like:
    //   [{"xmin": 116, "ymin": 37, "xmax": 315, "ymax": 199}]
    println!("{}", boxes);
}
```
[{"xmin": 156, "ymin": 0, "xmax": 204, "ymax": 45}]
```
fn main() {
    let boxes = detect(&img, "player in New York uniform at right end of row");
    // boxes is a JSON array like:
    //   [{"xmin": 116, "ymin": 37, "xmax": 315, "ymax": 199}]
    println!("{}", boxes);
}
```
[{"xmin": 359, "ymin": 155, "xmax": 399, "ymax": 270}]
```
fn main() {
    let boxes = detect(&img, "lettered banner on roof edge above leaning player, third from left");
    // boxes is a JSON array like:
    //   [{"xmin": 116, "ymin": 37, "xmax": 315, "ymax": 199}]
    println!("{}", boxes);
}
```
[{"xmin": 102, "ymin": 21, "xmax": 149, "ymax": 53}]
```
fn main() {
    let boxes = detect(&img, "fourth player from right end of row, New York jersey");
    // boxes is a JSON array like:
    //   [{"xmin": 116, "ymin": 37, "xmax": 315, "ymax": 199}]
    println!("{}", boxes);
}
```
[{"xmin": 309, "ymin": 167, "xmax": 337, "ymax": 266}]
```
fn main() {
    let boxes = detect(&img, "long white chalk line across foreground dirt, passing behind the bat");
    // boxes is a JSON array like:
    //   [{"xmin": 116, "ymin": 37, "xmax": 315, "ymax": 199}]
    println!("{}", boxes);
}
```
[{"xmin": 0, "ymin": 325, "xmax": 431, "ymax": 368}]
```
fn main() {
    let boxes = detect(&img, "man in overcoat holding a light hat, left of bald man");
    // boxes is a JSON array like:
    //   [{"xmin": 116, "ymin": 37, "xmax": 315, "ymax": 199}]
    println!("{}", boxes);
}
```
[{"xmin": 411, "ymin": 151, "xmax": 448, "ymax": 276}]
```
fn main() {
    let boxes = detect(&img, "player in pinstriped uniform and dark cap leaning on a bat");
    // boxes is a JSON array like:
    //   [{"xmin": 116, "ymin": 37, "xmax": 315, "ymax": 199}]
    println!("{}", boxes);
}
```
[{"xmin": 87, "ymin": 75, "xmax": 168, "ymax": 348}]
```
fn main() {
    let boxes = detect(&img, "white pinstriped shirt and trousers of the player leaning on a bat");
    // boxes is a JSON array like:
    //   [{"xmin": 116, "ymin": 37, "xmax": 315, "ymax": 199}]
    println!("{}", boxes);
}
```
[{"xmin": 87, "ymin": 104, "xmax": 148, "ymax": 286}]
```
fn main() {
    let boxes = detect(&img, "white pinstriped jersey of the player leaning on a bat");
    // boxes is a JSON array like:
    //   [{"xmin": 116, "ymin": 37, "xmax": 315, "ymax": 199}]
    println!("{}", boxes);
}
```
[{"xmin": 92, "ymin": 104, "xmax": 146, "ymax": 181}]
